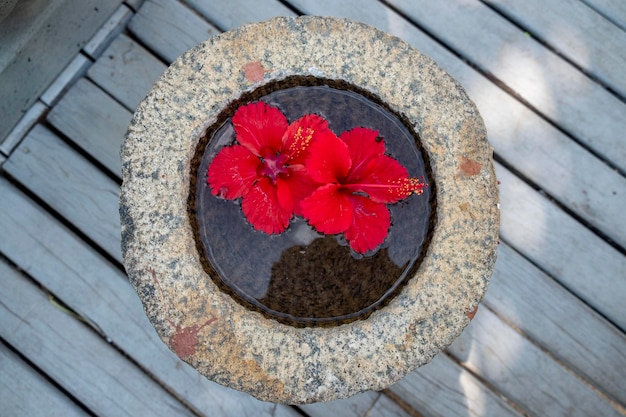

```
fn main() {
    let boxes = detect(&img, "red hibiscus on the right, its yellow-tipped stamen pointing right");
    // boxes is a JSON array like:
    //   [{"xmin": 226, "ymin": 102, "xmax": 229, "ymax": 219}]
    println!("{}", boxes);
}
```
[{"xmin": 301, "ymin": 127, "xmax": 426, "ymax": 253}]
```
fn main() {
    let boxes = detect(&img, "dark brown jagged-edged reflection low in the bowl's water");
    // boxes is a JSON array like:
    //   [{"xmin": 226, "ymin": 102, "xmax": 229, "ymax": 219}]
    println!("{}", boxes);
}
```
[{"xmin": 259, "ymin": 236, "xmax": 406, "ymax": 319}]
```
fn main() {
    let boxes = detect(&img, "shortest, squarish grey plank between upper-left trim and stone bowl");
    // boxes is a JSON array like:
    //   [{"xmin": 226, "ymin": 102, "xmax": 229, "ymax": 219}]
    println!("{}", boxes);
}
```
[{"xmin": 87, "ymin": 34, "xmax": 166, "ymax": 111}]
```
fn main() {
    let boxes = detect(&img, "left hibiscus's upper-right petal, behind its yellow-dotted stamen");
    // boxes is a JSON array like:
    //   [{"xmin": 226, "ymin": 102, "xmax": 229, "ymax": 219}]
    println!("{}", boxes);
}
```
[{"xmin": 283, "ymin": 114, "xmax": 334, "ymax": 164}]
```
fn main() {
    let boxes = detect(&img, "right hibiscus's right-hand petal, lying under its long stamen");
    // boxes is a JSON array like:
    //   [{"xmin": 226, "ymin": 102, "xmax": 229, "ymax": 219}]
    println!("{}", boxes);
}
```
[{"xmin": 345, "ymin": 155, "xmax": 411, "ymax": 203}]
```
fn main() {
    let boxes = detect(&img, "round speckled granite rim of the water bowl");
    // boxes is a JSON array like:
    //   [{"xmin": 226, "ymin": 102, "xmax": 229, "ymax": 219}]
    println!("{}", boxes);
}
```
[{"xmin": 120, "ymin": 17, "xmax": 499, "ymax": 403}]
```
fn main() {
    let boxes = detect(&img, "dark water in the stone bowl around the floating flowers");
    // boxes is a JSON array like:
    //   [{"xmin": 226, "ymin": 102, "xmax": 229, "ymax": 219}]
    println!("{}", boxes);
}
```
[{"xmin": 195, "ymin": 86, "xmax": 432, "ymax": 326}]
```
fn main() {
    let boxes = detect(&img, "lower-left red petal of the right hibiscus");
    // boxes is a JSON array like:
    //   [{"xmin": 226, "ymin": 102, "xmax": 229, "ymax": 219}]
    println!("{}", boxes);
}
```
[{"xmin": 300, "ymin": 184, "xmax": 352, "ymax": 234}]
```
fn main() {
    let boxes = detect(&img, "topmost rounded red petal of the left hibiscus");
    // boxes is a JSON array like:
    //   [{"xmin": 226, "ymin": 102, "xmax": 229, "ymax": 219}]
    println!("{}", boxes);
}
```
[{"xmin": 233, "ymin": 101, "xmax": 289, "ymax": 156}]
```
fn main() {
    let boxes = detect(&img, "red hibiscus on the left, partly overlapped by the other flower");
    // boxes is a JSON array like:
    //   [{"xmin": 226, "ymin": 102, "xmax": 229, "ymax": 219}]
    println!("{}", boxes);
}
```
[{"xmin": 207, "ymin": 102, "xmax": 334, "ymax": 234}]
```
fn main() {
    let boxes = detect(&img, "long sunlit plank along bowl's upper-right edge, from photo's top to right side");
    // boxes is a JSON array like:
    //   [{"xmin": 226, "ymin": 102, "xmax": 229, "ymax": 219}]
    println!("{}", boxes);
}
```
[{"xmin": 290, "ymin": 0, "xmax": 626, "ymax": 247}]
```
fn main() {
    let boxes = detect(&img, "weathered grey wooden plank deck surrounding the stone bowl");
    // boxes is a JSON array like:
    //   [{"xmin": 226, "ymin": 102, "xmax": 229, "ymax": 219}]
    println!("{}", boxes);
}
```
[{"xmin": 0, "ymin": 0, "xmax": 626, "ymax": 417}]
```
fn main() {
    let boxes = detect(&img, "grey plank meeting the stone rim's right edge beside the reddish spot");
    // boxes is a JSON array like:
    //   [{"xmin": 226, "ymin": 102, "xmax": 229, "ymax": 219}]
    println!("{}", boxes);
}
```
[{"xmin": 496, "ymin": 163, "xmax": 626, "ymax": 331}]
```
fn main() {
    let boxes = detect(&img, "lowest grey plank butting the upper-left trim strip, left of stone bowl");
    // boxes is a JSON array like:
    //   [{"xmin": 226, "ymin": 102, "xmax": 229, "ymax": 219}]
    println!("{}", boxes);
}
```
[{"xmin": 3, "ymin": 125, "xmax": 122, "ymax": 262}]
